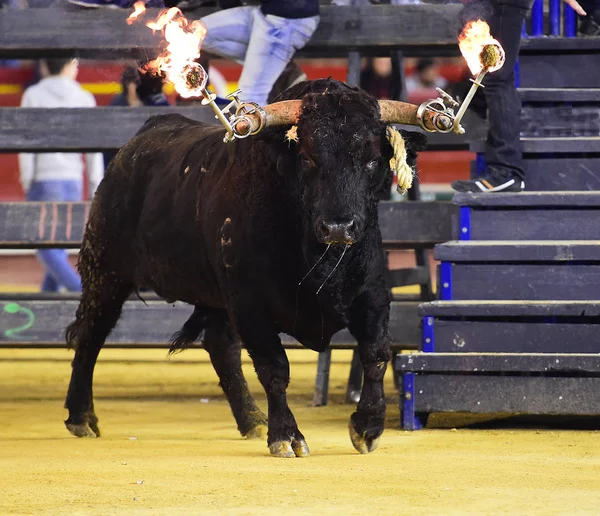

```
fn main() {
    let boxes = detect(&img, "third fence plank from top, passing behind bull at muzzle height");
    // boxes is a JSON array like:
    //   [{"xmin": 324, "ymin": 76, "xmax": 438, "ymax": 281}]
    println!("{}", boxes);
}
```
[{"xmin": 0, "ymin": 201, "xmax": 457, "ymax": 249}]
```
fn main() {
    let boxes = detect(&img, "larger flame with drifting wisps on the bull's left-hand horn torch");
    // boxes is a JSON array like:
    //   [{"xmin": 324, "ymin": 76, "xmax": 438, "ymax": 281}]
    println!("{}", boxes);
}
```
[{"xmin": 127, "ymin": 2, "xmax": 208, "ymax": 98}]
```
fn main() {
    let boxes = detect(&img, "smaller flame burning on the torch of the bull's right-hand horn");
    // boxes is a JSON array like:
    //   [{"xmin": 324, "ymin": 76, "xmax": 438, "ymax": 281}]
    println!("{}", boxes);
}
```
[{"xmin": 458, "ymin": 20, "xmax": 504, "ymax": 75}]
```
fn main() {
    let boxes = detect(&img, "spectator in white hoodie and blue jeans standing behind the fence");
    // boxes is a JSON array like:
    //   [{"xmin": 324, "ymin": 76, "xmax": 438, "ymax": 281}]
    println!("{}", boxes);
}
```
[{"xmin": 19, "ymin": 59, "xmax": 104, "ymax": 292}]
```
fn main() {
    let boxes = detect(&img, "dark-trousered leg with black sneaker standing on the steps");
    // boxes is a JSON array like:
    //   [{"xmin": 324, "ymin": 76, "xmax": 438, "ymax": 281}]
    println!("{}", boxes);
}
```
[{"xmin": 452, "ymin": 0, "xmax": 532, "ymax": 192}]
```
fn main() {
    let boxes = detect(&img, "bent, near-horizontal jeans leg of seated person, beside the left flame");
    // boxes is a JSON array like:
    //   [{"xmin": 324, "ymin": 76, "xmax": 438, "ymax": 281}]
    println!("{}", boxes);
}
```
[{"xmin": 200, "ymin": 6, "xmax": 258, "ymax": 64}]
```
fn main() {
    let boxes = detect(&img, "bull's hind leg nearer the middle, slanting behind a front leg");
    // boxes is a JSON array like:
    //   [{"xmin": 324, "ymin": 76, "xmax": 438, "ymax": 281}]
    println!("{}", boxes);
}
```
[{"xmin": 204, "ymin": 318, "xmax": 267, "ymax": 439}]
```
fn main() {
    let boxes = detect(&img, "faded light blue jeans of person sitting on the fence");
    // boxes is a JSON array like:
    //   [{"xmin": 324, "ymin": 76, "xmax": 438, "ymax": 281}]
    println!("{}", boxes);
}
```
[{"xmin": 201, "ymin": 6, "xmax": 319, "ymax": 106}]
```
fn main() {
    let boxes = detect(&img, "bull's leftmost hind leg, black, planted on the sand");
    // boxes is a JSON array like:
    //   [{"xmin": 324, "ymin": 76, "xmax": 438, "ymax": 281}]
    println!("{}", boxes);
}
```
[{"xmin": 65, "ymin": 267, "xmax": 132, "ymax": 437}]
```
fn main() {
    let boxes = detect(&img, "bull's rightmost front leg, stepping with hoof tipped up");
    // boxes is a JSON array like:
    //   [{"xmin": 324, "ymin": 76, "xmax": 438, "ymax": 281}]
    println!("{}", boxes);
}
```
[{"xmin": 348, "ymin": 277, "xmax": 391, "ymax": 453}]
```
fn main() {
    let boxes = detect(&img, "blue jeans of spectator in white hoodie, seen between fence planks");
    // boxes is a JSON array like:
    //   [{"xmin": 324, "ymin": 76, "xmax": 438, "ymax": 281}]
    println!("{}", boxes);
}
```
[{"xmin": 27, "ymin": 181, "xmax": 83, "ymax": 292}]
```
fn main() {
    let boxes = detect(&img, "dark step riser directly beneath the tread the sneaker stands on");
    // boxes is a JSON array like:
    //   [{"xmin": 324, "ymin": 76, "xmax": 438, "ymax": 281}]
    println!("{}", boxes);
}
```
[{"xmin": 470, "ymin": 209, "xmax": 600, "ymax": 240}]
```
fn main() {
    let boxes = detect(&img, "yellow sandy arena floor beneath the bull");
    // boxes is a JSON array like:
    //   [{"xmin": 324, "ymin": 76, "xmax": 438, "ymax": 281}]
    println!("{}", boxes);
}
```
[{"xmin": 0, "ymin": 350, "xmax": 600, "ymax": 515}]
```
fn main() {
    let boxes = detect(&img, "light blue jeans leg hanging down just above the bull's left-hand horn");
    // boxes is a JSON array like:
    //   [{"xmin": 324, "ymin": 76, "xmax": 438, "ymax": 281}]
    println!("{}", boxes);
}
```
[{"xmin": 239, "ymin": 9, "xmax": 319, "ymax": 105}]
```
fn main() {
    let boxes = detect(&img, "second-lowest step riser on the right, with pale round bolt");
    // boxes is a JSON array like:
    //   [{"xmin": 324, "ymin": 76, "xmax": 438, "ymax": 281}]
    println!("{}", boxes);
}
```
[{"xmin": 433, "ymin": 318, "xmax": 600, "ymax": 353}]
